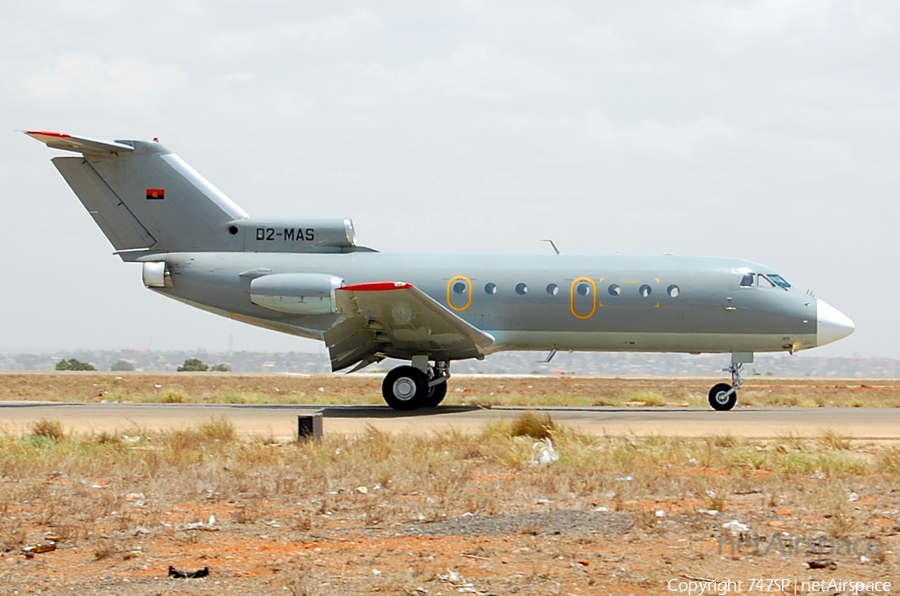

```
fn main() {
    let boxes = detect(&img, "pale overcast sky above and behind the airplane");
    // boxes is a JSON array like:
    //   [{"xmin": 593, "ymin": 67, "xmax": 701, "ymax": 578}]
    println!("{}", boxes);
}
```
[{"xmin": 0, "ymin": 0, "xmax": 900, "ymax": 358}]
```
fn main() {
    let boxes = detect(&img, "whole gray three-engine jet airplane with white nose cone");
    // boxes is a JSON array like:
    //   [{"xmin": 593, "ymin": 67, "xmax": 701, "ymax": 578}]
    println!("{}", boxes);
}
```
[{"xmin": 24, "ymin": 130, "xmax": 855, "ymax": 411}]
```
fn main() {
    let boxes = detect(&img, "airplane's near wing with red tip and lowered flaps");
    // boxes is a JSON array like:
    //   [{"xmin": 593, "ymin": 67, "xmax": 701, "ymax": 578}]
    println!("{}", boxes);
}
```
[{"xmin": 325, "ymin": 281, "xmax": 494, "ymax": 371}]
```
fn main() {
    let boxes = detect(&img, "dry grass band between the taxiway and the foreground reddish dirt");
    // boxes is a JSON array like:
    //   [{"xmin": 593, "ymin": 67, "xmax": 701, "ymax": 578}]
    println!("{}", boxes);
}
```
[{"xmin": 0, "ymin": 420, "xmax": 900, "ymax": 528}]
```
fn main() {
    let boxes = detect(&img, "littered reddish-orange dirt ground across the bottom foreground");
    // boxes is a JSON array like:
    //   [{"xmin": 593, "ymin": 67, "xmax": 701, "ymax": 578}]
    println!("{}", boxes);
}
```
[{"xmin": 7, "ymin": 452, "xmax": 900, "ymax": 595}]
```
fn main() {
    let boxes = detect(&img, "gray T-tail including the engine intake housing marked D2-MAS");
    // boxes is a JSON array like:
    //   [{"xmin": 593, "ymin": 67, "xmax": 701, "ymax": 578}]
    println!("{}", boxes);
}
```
[{"xmin": 25, "ymin": 131, "xmax": 365, "ymax": 260}]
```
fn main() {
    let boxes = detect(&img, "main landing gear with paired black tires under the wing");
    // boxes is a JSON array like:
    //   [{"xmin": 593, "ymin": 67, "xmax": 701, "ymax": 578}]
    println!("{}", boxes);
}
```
[{"xmin": 381, "ymin": 357, "xmax": 450, "ymax": 410}]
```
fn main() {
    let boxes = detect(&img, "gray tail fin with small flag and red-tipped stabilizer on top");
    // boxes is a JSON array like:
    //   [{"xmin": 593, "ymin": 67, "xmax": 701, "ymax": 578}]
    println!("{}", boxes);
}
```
[{"xmin": 25, "ymin": 131, "xmax": 248, "ymax": 252}]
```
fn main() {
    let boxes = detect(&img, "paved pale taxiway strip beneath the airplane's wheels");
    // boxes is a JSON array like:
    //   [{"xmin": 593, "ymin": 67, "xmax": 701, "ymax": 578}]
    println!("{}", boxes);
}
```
[{"xmin": 0, "ymin": 402, "xmax": 900, "ymax": 441}]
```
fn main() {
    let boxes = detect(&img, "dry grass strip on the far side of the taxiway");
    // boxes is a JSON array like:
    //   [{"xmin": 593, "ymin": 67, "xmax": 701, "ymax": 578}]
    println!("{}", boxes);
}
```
[{"xmin": 0, "ymin": 372, "xmax": 900, "ymax": 408}]
